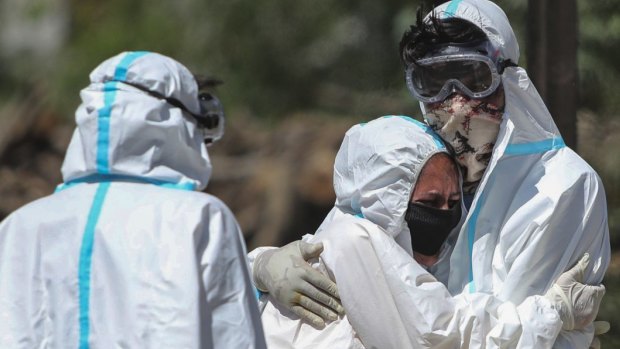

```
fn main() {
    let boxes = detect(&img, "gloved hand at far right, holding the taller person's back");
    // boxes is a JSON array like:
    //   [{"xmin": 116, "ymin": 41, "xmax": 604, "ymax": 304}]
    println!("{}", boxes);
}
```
[{"xmin": 545, "ymin": 253, "xmax": 605, "ymax": 331}]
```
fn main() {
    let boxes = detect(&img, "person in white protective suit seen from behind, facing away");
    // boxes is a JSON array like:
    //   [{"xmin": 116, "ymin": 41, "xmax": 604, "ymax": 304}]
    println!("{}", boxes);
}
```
[{"xmin": 0, "ymin": 52, "xmax": 265, "ymax": 349}]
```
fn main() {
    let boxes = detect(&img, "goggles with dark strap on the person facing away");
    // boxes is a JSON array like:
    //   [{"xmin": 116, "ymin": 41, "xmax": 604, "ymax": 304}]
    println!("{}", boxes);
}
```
[{"xmin": 123, "ymin": 81, "xmax": 224, "ymax": 145}]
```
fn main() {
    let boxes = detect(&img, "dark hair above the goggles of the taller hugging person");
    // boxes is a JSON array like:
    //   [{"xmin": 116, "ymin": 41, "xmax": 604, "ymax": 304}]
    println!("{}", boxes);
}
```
[{"xmin": 399, "ymin": 7, "xmax": 488, "ymax": 66}]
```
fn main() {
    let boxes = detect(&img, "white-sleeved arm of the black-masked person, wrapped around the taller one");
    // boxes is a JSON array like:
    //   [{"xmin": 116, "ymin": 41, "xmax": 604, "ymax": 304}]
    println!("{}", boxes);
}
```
[{"xmin": 318, "ymin": 217, "xmax": 562, "ymax": 348}]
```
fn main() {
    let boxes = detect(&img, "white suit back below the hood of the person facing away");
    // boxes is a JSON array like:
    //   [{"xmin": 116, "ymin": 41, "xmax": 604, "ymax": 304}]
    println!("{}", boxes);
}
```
[{"xmin": 0, "ymin": 182, "xmax": 253, "ymax": 348}]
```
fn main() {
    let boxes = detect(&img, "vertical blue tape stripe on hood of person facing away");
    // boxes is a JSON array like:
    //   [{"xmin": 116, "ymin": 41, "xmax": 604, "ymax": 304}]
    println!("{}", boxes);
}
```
[{"xmin": 97, "ymin": 51, "xmax": 148, "ymax": 174}]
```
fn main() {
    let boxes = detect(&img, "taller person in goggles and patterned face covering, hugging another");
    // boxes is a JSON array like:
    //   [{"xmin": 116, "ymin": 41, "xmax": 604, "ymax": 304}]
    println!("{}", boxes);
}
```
[{"xmin": 252, "ymin": 0, "xmax": 610, "ymax": 348}]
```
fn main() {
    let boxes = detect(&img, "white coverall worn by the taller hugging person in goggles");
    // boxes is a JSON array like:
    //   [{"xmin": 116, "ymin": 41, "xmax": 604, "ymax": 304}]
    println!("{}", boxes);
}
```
[{"xmin": 421, "ymin": 0, "xmax": 610, "ymax": 348}]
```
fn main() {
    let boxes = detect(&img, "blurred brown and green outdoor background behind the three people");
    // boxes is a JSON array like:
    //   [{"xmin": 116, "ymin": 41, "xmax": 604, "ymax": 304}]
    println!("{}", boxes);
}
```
[{"xmin": 0, "ymin": 0, "xmax": 620, "ymax": 342}]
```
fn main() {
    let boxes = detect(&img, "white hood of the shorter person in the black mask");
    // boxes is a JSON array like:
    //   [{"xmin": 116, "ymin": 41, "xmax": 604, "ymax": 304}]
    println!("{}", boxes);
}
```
[{"xmin": 334, "ymin": 116, "xmax": 448, "ymax": 243}]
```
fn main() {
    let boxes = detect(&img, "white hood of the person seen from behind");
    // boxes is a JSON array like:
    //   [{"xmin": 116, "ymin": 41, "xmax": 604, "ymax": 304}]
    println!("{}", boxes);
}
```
[{"xmin": 62, "ymin": 52, "xmax": 211, "ymax": 190}]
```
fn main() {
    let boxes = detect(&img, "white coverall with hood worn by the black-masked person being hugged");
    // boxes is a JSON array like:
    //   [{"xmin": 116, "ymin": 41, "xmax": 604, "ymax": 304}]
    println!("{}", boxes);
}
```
[{"xmin": 258, "ymin": 116, "xmax": 562, "ymax": 349}]
